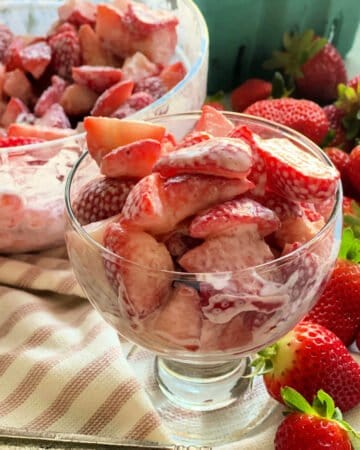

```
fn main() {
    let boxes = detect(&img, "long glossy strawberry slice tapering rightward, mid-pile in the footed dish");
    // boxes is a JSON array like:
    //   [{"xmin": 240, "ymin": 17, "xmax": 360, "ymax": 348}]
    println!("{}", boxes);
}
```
[{"xmin": 123, "ymin": 173, "xmax": 252, "ymax": 234}]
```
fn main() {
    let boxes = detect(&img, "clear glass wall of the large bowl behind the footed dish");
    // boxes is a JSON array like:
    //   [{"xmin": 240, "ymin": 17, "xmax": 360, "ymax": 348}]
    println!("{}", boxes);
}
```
[{"xmin": 0, "ymin": 0, "xmax": 209, "ymax": 253}]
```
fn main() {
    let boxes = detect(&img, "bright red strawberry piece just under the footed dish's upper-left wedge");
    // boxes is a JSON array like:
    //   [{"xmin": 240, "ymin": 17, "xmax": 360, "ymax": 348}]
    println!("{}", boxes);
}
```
[{"xmin": 100, "ymin": 139, "xmax": 161, "ymax": 178}]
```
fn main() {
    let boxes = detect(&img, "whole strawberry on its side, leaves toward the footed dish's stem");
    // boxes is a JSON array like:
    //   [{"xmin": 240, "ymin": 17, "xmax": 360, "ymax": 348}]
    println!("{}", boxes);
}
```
[{"xmin": 254, "ymin": 322, "xmax": 360, "ymax": 412}]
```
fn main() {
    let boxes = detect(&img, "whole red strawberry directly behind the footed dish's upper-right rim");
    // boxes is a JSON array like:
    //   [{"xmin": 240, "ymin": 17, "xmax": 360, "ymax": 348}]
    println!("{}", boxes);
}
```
[{"xmin": 244, "ymin": 98, "xmax": 329, "ymax": 145}]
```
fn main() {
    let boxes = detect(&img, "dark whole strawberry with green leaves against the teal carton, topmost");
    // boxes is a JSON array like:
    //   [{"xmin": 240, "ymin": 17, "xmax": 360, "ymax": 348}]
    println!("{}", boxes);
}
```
[{"xmin": 265, "ymin": 30, "xmax": 347, "ymax": 103}]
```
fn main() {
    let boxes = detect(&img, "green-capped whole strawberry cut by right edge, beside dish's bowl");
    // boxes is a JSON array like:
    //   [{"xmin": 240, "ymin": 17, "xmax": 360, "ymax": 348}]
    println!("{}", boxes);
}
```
[{"xmin": 305, "ymin": 229, "xmax": 360, "ymax": 346}]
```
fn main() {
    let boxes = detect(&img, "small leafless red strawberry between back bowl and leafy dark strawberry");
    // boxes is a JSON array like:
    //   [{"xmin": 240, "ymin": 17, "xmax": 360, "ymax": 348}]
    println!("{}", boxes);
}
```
[{"xmin": 230, "ymin": 78, "xmax": 272, "ymax": 112}]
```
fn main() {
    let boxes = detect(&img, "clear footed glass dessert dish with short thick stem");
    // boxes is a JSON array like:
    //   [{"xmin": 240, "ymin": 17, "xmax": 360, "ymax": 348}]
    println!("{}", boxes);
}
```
[{"xmin": 65, "ymin": 112, "xmax": 342, "ymax": 445}]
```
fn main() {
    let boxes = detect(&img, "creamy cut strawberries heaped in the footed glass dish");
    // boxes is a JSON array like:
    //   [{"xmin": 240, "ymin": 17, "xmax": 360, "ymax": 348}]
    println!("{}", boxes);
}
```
[{"xmin": 66, "ymin": 106, "xmax": 339, "ymax": 354}]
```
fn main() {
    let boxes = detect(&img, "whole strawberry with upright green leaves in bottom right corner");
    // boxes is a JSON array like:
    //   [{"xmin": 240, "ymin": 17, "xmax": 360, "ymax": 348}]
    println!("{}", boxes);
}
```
[{"xmin": 274, "ymin": 387, "xmax": 360, "ymax": 450}]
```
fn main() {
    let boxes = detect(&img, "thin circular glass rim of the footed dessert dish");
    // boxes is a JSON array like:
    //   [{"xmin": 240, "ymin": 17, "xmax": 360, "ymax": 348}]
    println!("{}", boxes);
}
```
[{"xmin": 65, "ymin": 111, "xmax": 343, "ymax": 279}]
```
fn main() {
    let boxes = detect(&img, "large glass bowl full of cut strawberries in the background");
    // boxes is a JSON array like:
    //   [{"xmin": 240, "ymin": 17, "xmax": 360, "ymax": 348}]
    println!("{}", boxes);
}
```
[{"xmin": 0, "ymin": 0, "xmax": 207, "ymax": 253}]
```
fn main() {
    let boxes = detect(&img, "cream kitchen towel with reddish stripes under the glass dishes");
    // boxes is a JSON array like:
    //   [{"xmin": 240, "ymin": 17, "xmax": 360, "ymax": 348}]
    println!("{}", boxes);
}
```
[{"xmin": 0, "ymin": 248, "xmax": 360, "ymax": 450}]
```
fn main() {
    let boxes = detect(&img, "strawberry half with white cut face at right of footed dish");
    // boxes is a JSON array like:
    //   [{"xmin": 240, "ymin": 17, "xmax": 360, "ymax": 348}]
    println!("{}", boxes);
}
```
[{"xmin": 257, "ymin": 138, "xmax": 340, "ymax": 202}]
